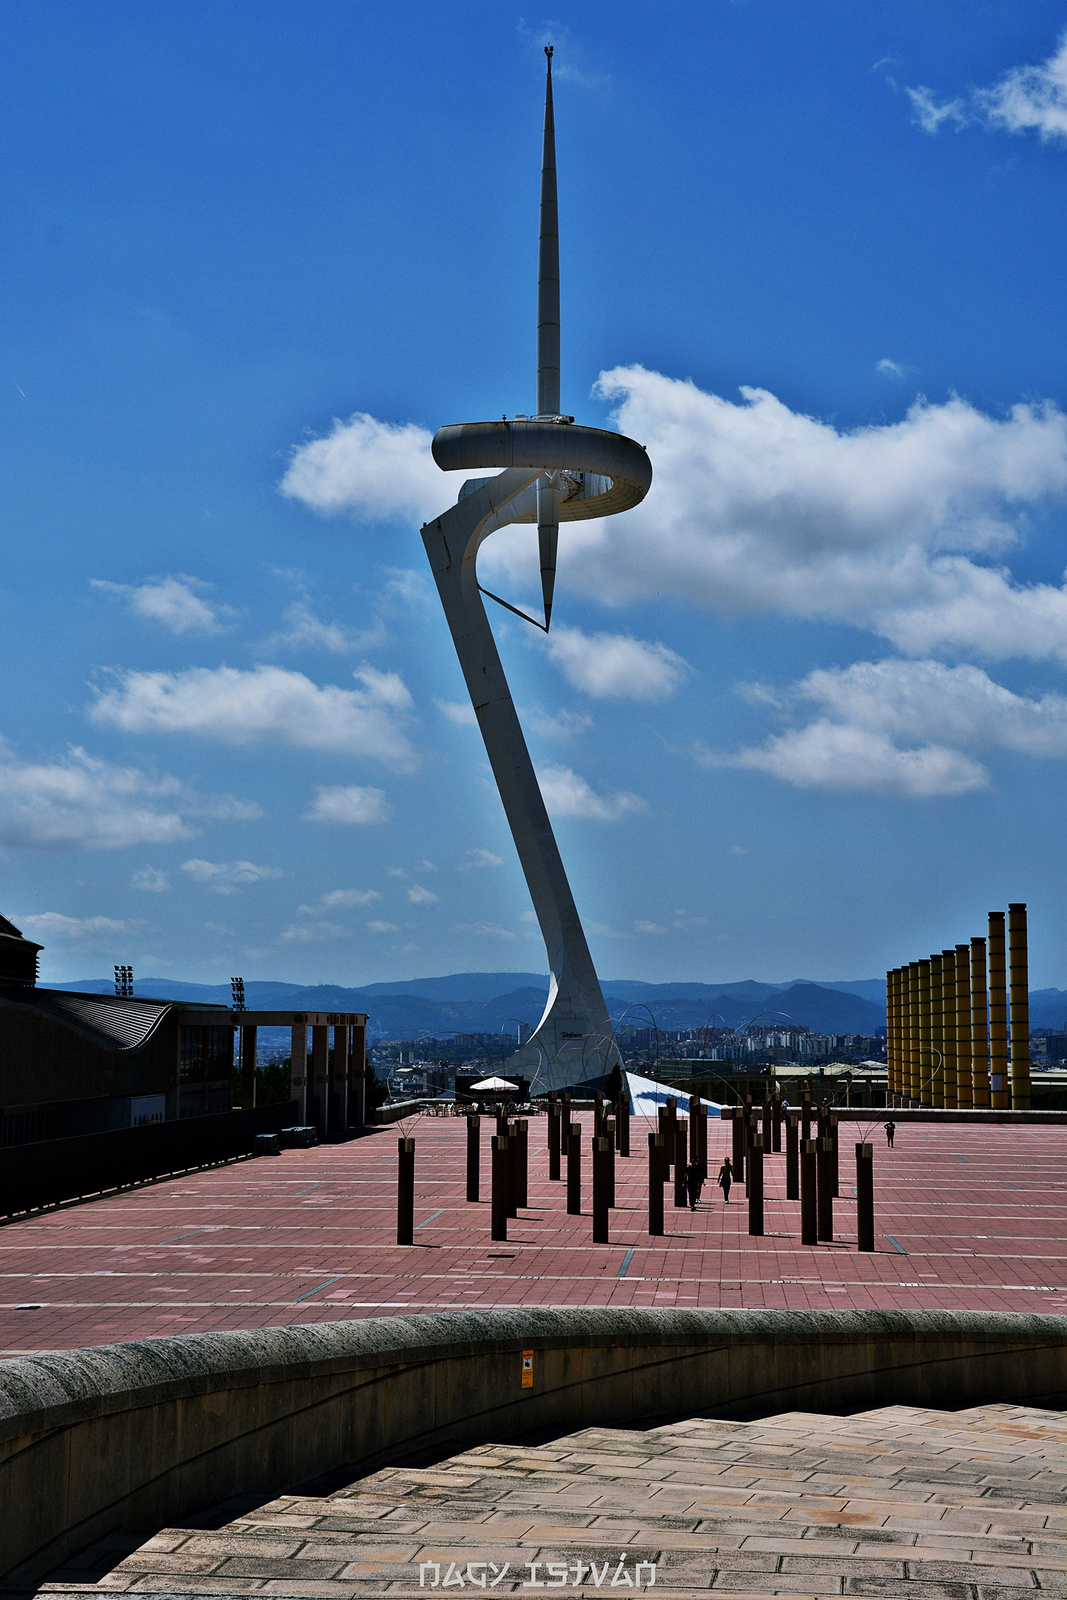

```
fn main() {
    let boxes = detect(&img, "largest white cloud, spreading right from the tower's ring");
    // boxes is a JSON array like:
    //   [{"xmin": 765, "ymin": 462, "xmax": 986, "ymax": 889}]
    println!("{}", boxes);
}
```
[{"xmin": 502, "ymin": 366, "xmax": 1067, "ymax": 659}]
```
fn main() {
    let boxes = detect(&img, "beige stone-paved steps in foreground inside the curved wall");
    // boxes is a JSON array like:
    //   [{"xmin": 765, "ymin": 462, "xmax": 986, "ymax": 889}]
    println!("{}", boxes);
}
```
[{"xmin": 38, "ymin": 1405, "xmax": 1067, "ymax": 1600}]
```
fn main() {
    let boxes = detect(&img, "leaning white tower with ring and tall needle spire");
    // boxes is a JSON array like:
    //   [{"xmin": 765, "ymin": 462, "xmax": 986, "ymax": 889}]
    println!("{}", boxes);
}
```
[{"xmin": 422, "ymin": 45, "xmax": 653, "ymax": 1088}]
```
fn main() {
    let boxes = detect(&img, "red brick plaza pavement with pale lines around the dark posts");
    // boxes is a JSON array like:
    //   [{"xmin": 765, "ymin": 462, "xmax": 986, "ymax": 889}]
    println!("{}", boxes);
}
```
[{"xmin": 0, "ymin": 1117, "xmax": 1067, "ymax": 1357}]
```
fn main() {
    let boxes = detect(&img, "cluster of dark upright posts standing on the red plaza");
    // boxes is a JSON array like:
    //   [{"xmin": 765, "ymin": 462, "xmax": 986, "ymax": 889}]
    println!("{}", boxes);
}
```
[{"xmin": 397, "ymin": 1091, "xmax": 875, "ymax": 1251}]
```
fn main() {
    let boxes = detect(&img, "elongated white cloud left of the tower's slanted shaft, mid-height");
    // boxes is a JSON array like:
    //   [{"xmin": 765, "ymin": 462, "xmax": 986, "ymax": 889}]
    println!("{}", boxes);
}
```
[{"xmin": 90, "ymin": 666, "xmax": 416, "ymax": 770}]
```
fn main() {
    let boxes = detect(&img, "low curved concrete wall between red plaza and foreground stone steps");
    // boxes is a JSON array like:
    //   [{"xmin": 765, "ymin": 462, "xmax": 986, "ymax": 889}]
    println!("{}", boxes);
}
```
[{"xmin": 0, "ymin": 1307, "xmax": 1067, "ymax": 1582}]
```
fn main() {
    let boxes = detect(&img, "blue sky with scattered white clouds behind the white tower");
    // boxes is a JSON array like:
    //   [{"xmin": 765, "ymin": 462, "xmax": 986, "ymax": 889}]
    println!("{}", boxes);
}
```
[{"xmin": 0, "ymin": 0, "xmax": 1067, "ymax": 984}]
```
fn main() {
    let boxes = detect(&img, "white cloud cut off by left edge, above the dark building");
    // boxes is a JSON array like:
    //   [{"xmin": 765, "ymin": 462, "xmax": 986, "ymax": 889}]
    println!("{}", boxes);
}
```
[{"xmin": 0, "ymin": 742, "xmax": 212, "ymax": 850}]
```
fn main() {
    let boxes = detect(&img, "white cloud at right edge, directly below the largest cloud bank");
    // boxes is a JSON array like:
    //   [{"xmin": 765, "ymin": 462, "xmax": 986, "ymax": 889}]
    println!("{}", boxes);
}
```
[{"xmin": 723, "ymin": 659, "xmax": 1067, "ymax": 797}]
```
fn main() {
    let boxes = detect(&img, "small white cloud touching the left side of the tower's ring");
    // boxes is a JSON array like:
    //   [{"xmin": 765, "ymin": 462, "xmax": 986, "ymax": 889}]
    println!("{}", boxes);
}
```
[{"xmin": 282, "ymin": 411, "xmax": 470, "ymax": 522}]
